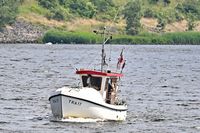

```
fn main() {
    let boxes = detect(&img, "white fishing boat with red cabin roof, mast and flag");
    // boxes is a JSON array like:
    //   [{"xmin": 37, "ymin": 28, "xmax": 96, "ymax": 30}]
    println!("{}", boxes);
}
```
[{"xmin": 49, "ymin": 29, "xmax": 127, "ymax": 121}]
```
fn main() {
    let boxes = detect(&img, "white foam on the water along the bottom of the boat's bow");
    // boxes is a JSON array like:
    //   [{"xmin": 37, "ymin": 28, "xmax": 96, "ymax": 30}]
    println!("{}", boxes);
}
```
[{"xmin": 50, "ymin": 117, "xmax": 104, "ymax": 123}]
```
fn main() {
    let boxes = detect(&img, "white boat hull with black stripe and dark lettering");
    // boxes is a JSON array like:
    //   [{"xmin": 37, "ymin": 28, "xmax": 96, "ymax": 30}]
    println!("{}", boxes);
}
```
[{"xmin": 49, "ymin": 87, "xmax": 127, "ymax": 121}]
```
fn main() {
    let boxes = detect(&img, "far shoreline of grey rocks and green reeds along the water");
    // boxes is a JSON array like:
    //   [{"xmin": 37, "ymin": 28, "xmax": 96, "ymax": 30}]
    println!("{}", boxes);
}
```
[{"xmin": 0, "ymin": 20, "xmax": 200, "ymax": 45}]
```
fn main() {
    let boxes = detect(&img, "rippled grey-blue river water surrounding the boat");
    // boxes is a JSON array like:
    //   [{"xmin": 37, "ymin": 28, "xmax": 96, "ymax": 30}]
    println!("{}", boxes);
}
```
[{"xmin": 0, "ymin": 44, "xmax": 200, "ymax": 133}]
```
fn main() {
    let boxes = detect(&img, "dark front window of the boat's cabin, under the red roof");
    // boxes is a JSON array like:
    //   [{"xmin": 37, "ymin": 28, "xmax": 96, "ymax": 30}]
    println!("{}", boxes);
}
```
[{"xmin": 82, "ymin": 75, "xmax": 102, "ymax": 91}]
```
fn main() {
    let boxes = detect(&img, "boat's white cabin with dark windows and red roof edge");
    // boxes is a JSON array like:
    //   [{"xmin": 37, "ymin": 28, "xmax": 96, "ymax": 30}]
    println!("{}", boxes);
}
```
[{"xmin": 76, "ymin": 70, "xmax": 123, "ymax": 104}]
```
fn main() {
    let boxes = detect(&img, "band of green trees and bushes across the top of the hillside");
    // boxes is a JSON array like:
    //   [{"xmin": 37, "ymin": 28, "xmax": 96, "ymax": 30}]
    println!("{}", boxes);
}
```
[{"xmin": 0, "ymin": 0, "xmax": 200, "ymax": 35}]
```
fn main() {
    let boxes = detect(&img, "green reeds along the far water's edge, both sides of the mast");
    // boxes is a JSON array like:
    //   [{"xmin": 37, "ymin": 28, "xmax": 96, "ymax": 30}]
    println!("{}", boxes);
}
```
[{"xmin": 43, "ymin": 30, "xmax": 200, "ymax": 45}]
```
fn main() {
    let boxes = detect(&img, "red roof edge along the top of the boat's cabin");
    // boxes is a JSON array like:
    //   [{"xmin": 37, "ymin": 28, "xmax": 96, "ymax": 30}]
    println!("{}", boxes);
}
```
[{"xmin": 76, "ymin": 70, "xmax": 123, "ymax": 77}]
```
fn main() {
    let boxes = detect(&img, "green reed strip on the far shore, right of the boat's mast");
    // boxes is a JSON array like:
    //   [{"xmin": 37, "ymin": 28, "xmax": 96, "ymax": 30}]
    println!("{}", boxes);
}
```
[{"xmin": 110, "ymin": 32, "xmax": 200, "ymax": 45}]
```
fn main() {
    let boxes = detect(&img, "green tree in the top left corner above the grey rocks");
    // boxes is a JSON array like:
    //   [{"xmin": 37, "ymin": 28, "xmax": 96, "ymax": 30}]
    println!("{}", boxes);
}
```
[{"xmin": 0, "ymin": 0, "xmax": 20, "ymax": 28}]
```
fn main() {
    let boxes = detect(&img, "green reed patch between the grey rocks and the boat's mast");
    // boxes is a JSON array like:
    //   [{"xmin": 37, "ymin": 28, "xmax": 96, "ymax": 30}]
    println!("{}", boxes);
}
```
[{"xmin": 43, "ymin": 30, "xmax": 101, "ymax": 44}]
